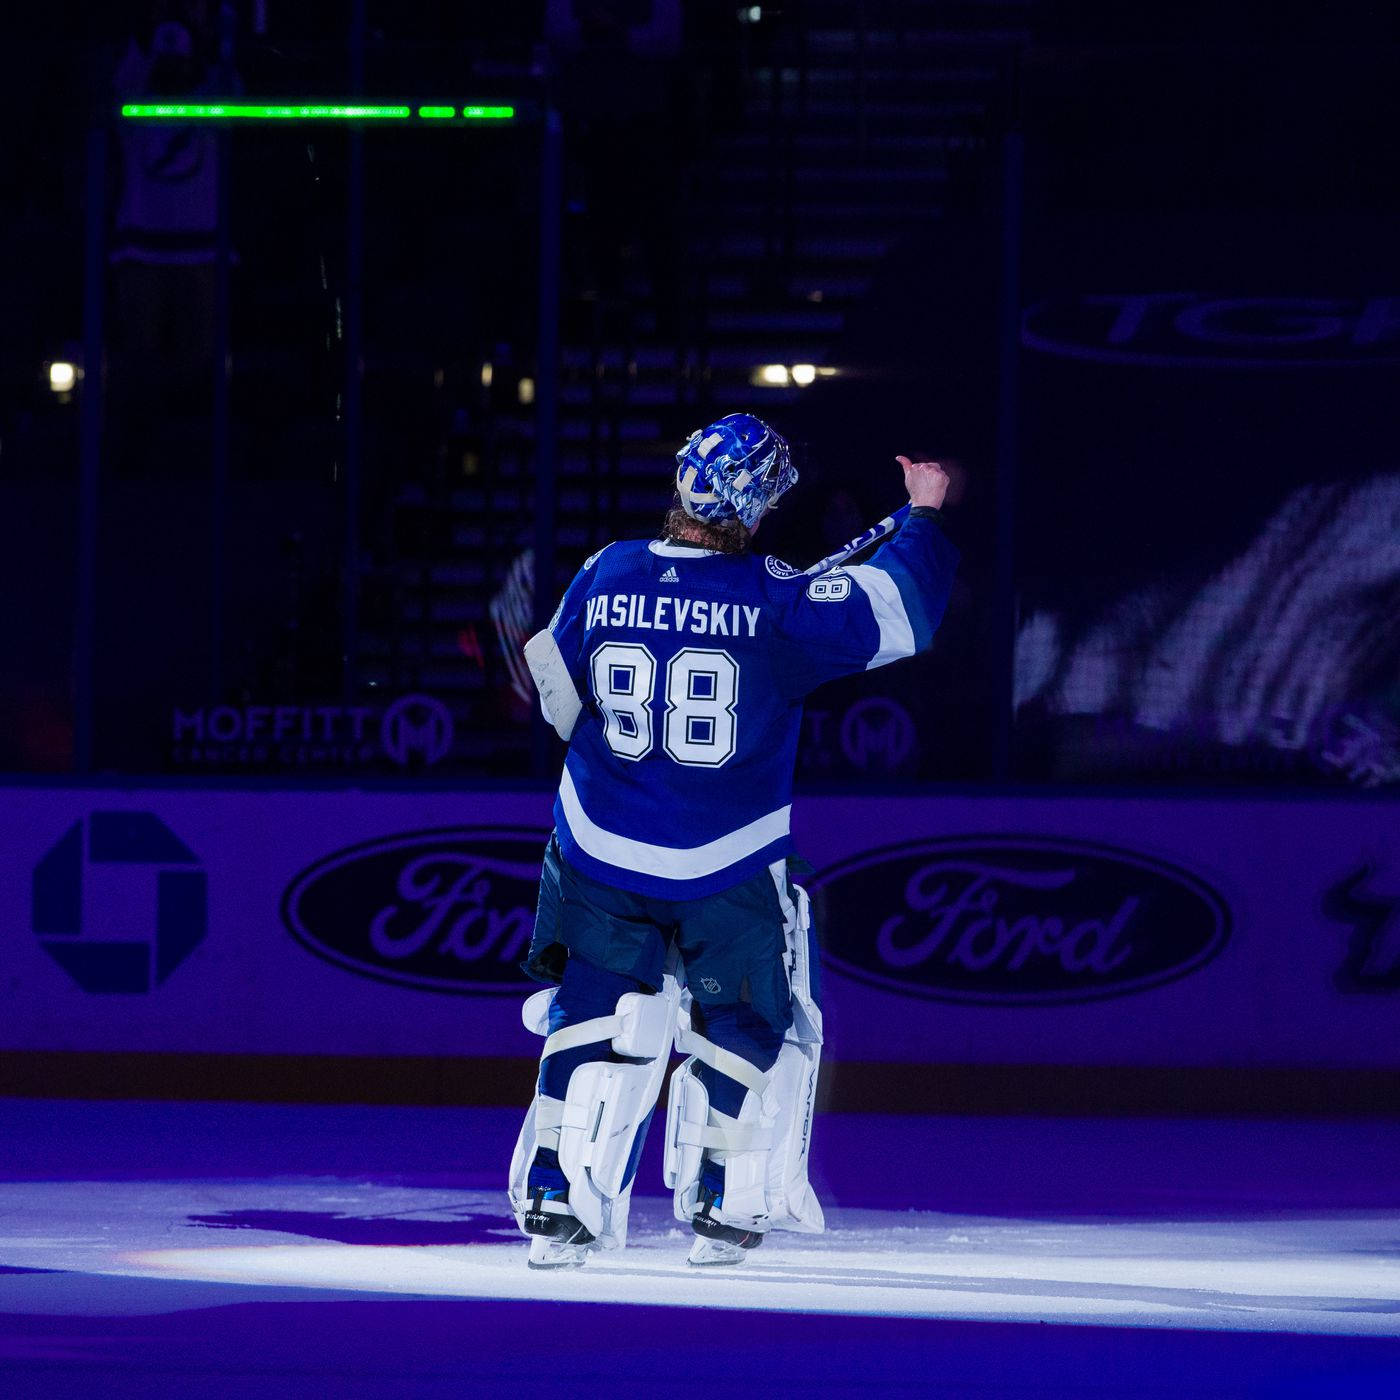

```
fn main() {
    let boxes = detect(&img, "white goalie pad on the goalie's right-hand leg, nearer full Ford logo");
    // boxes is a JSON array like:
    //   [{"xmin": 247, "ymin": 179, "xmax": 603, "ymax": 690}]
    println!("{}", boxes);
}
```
[{"xmin": 665, "ymin": 861, "xmax": 826, "ymax": 1233}]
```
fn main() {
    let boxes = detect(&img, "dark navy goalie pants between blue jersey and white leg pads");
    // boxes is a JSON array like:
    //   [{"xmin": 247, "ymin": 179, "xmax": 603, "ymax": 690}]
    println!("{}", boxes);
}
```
[{"xmin": 525, "ymin": 839, "xmax": 819, "ymax": 1125}]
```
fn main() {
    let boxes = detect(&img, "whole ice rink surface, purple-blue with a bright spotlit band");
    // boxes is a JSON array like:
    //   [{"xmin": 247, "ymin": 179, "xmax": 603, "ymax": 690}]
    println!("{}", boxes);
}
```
[{"xmin": 0, "ymin": 1100, "xmax": 1400, "ymax": 1400}]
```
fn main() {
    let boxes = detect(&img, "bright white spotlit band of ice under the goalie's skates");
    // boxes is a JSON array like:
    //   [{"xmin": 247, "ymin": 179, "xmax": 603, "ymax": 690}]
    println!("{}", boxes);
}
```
[{"xmin": 0, "ymin": 1177, "xmax": 1400, "ymax": 1336}]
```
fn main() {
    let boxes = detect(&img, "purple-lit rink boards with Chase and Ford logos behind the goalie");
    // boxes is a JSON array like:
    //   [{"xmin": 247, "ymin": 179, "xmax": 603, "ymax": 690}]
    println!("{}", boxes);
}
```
[{"xmin": 0, "ymin": 787, "xmax": 1400, "ymax": 1068}]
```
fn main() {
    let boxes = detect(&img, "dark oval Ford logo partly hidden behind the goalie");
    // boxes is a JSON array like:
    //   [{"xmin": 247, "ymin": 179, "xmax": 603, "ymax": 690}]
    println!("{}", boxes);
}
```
[{"xmin": 281, "ymin": 826, "xmax": 549, "ymax": 993}]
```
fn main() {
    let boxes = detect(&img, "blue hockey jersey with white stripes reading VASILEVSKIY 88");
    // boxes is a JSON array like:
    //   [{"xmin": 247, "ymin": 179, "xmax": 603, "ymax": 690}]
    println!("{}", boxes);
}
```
[{"xmin": 550, "ymin": 517, "xmax": 958, "ymax": 899}]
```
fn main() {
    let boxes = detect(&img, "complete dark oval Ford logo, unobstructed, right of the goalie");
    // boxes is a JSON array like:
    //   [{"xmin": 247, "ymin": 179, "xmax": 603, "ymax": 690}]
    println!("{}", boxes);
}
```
[{"xmin": 811, "ymin": 836, "xmax": 1231, "ymax": 1005}]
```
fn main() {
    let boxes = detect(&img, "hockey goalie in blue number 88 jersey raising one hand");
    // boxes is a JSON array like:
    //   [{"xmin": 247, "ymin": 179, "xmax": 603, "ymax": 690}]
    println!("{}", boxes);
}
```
[{"xmin": 510, "ymin": 413, "xmax": 958, "ymax": 1268}]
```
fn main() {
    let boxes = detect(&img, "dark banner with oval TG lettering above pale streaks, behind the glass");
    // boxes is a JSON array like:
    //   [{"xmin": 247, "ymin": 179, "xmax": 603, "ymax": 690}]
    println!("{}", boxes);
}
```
[{"xmin": 1015, "ymin": 198, "xmax": 1400, "ymax": 792}]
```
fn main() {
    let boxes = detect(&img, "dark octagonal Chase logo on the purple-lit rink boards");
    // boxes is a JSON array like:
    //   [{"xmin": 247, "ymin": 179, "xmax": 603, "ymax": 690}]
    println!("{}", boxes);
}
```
[{"xmin": 34, "ymin": 812, "xmax": 209, "ymax": 993}]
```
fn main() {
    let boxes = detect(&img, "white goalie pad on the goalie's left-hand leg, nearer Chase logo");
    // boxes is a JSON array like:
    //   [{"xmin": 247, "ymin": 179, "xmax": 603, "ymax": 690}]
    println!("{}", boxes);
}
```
[{"xmin": 510, "ymin": 974, "xmax": 680, "ymax": 1249}]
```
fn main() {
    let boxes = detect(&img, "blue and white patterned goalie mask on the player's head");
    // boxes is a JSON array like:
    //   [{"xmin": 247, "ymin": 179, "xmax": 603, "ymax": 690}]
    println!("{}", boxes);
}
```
[{"xmin": 676, "ymin": 413, "xmax": 797, "ymax": 529}]
